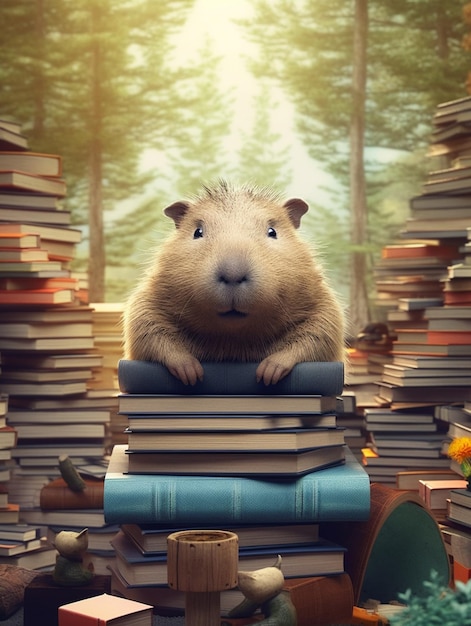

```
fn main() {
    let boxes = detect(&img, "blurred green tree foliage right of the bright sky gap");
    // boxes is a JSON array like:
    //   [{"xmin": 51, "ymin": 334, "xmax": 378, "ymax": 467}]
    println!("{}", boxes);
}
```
[{"xmin": 242, "ymin": 0, "xmax": 469, "ymax": 330}]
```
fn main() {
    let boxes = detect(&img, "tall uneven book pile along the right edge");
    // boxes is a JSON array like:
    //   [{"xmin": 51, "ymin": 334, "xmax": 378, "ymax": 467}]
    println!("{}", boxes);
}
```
[{"xmin": 365, "ymin": 97, "xmax": 471, "ymax": 480}]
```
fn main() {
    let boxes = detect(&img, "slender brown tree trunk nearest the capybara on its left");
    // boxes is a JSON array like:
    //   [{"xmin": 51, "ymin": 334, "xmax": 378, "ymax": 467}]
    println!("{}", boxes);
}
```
[{"xmin": 88, "ymin": 7, "xmax": 106, "ymax": 302}]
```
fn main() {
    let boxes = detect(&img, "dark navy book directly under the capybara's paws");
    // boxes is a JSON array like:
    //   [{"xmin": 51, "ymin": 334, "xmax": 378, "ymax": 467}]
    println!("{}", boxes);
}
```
[{"xmin": 118, "ymin": 359, "xmax": 344, "ymax": 396}]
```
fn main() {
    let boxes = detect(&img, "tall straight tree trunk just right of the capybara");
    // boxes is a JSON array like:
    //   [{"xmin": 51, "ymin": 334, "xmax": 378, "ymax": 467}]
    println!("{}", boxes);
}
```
[{"xmin": 349, "ymin": 0, "xmax": 369, "ymax": 335}]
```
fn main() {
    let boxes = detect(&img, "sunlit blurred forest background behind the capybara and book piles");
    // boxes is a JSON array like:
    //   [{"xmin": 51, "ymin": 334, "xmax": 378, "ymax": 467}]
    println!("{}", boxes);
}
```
[{"xmin": 0, "ymin": 0, "xmax": 471, "ymax": 331}]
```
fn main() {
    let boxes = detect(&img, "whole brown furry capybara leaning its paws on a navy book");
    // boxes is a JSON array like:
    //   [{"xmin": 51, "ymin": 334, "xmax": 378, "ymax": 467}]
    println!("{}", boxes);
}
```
[{"xmin": 124, "ymin": 181, "xmax": 344, "ymax": 384}]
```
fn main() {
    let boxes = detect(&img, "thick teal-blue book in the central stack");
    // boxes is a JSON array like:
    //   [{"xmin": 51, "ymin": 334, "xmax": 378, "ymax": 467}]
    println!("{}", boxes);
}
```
[{"xmin": 104, "ymin": 445, "xmax": 370, "ymax": 526}]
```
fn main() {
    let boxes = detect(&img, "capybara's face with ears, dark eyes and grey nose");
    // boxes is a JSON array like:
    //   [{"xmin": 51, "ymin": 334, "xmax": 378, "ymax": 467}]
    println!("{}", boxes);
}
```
[{"xmin": 161, "ymin": 188, "xmax": 314, "ymax": 333}]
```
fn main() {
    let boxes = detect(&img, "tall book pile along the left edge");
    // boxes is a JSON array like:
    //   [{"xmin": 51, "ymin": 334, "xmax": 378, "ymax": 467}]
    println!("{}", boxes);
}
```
[{"xmin": 0, "ymin": 120, "xmax": 116, "ymax": 564}]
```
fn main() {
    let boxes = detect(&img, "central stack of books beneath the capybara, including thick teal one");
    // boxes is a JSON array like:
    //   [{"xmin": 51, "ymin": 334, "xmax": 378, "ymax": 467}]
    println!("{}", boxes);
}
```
[{"xmin": 104, "ymin": 360, "xmax": 370, "ymax": 624}]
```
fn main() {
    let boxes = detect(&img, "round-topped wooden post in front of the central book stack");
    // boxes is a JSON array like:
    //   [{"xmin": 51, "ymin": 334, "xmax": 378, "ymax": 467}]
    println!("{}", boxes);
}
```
[{"xmin": 167, "ymin": 530, "xmax": 239, "ymax": 626}]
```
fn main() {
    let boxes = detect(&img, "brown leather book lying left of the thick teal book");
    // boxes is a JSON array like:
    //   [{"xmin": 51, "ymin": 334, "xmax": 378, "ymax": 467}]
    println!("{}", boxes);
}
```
[{"xmin": 39, "ymin": 478, "xmax": 104, "ymax": 510}]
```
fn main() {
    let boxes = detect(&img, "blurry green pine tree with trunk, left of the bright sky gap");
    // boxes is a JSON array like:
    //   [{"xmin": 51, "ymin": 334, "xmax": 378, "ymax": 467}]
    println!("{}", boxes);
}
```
[{"xmin": 0, "ymin": 0, "xmax": 192, "ymax": 301}]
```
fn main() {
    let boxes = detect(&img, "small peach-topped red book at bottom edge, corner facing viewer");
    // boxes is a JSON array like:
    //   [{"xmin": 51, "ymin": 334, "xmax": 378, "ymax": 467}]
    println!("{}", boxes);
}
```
[{"xmin": 58, "ymin": 593, "xmax": 153, "ymax": 626}]
